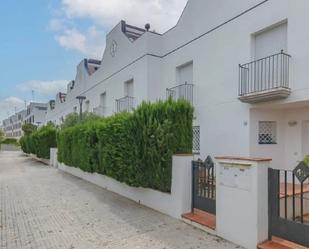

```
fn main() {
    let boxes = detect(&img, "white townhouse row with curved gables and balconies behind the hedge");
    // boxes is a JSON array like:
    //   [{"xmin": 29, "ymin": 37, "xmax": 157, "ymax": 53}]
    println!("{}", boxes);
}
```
[{"xmin": 46, "ymin": 0, "xmax": 309, "ymax": 169}]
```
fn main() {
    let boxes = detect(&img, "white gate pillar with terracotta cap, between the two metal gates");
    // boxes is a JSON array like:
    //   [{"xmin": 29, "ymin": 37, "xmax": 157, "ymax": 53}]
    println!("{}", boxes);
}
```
[{"xmin": 216, "ymin": 157, "xmax": 271, "ymax": 249}]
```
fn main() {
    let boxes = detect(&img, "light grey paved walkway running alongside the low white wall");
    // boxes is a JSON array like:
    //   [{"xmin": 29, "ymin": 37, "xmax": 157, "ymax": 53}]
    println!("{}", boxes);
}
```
[{"xmin": 0, "ymin": 151, "xmax": 238, "ymax": 249}]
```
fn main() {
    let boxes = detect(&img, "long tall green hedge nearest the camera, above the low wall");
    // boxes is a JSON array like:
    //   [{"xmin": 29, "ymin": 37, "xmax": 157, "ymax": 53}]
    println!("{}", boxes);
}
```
[{"xmin": 58, "ymin": 100, "xmax": 193, "ymax": 192}]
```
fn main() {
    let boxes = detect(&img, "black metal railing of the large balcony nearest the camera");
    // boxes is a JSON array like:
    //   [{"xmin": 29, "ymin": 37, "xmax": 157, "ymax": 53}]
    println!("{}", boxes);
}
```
[{"xmin": 239, "ymin": 50, "xmax": 291, "ymax": 96}]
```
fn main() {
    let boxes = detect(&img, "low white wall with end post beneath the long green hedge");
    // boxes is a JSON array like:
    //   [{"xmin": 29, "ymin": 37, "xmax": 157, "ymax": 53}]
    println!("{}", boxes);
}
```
[{"xmin": 51, "ymin": 153, "xmax": 193, "ymax": 219}]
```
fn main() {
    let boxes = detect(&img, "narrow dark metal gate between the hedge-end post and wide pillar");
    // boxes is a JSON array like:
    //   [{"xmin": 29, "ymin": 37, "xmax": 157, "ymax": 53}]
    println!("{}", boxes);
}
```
[{"xmin": 192, "ymin": 156, "xmax": 216, "ymax": 214}]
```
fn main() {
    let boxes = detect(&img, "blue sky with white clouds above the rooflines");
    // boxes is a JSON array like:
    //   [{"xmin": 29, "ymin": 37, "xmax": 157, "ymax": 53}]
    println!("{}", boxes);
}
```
[{"xmin": 0, "ymin": 0, "xmax": 187, "ymax": 122}]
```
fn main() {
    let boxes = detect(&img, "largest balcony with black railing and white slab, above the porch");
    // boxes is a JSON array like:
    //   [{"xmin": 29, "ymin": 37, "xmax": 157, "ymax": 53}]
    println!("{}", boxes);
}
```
[{"xmin": 239, "ymin": 51, "xmax": 291, "ymax": 104}]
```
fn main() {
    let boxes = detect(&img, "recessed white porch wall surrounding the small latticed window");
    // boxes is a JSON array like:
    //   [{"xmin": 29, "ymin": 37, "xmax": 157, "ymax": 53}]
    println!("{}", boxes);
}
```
[{"xmin": 250, "ymin": 106, "xmax": 309, "ymax": 170}]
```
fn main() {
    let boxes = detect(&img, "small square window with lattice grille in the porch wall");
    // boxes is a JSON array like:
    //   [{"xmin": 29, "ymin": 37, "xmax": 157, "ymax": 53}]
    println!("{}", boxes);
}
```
[{"xmin": 259, "ymin": 121, "xmax": 277, "ymax": 144}]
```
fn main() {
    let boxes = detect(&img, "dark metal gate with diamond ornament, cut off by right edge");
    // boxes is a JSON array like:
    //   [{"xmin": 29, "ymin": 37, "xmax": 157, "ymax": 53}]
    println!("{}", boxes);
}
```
[{"xmin": 268, "ymin": 162, "xmax": 309, "ymax": 246}]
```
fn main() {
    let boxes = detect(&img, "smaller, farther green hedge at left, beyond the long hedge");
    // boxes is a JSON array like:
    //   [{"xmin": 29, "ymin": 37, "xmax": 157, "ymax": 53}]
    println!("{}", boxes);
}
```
[{"xmin": 20, "ymin": 124, "xmax": 57, "ymax": 159}]
